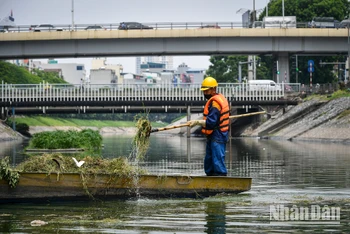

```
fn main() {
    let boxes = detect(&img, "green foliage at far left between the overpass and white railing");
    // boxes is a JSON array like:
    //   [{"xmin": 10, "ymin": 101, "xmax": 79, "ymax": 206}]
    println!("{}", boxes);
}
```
[{"xmin": 0, "ymin": 61, "xmax": 66, "ymax": 84}]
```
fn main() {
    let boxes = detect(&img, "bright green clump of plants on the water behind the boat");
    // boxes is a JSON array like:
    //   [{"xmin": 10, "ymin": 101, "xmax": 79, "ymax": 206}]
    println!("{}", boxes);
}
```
[{"xmin": 28, "ymin": 129, "xmax": 102, "ymax": 150}]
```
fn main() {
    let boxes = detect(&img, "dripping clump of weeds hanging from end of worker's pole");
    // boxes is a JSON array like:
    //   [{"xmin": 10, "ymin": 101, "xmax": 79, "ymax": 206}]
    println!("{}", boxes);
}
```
[{"xmin": 130, "ymin": 115, "xmax": 152, "ymax": 162}]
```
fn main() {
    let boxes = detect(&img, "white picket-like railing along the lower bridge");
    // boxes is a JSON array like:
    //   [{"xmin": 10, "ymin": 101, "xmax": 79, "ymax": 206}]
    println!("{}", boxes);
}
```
[{"xmin": 0, "ymin": 82, "xmax": 290, "ymax": 102}]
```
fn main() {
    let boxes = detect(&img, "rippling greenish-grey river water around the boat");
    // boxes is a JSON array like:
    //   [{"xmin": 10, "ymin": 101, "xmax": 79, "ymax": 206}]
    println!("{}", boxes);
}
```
[{"xmin": 0, "ymin": 134, "xmax": 350, "ymax": 234}]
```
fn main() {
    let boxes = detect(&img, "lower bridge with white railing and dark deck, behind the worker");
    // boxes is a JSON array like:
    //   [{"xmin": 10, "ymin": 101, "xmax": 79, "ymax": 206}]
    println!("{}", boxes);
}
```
[{"xmin": 0, "ymin": 82, "xmax": 300, "ymax": 116}]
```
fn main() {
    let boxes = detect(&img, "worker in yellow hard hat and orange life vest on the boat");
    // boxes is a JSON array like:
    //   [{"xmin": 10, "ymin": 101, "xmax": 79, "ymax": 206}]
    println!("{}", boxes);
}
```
[{"xmin": 189, "ymin": 77, "xmax": 230, "ymax": 176}]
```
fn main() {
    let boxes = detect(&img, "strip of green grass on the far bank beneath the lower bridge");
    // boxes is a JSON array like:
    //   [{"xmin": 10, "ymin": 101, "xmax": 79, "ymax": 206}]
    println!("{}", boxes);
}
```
[{"xmin": 15, "ymin": 116, "xmax": 167, "ymax": 128}]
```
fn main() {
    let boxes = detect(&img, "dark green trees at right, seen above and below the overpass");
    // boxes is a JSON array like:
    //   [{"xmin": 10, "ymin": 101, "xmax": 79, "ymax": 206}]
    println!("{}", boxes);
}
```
[{"xmin": 207, "ymin": 0, "xmax": 350, "ymax": 84}]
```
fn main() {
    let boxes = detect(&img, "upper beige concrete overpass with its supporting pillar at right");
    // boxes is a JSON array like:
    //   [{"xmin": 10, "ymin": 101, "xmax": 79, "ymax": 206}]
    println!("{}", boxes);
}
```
[{"xmin": 0, "ymin": 24, "xmax": 349, "ymax": 82}]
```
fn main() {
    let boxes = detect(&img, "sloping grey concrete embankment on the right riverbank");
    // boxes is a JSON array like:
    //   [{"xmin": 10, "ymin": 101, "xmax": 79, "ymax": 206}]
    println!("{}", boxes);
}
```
[{"xmin": 244, "ymin": 97, "xmax": 350, "ymax": 143}]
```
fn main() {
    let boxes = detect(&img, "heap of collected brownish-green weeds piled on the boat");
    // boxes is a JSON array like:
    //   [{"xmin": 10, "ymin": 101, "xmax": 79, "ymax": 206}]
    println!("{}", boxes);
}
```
[{"xmin": 0, "ymin": 153, "xmax": 147, "ymax": 190}]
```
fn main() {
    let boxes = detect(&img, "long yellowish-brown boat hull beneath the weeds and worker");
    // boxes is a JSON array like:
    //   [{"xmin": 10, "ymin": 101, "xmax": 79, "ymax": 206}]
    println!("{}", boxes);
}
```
[{"xmin": 0, "ymin": 173, "xmax": 252, "ymax": 203}]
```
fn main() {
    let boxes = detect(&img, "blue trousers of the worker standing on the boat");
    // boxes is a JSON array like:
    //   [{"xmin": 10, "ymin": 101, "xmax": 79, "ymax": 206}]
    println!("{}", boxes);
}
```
[{"xmin": 204, "ymin": 139, "xmax": 227, "ymax": 176}]
